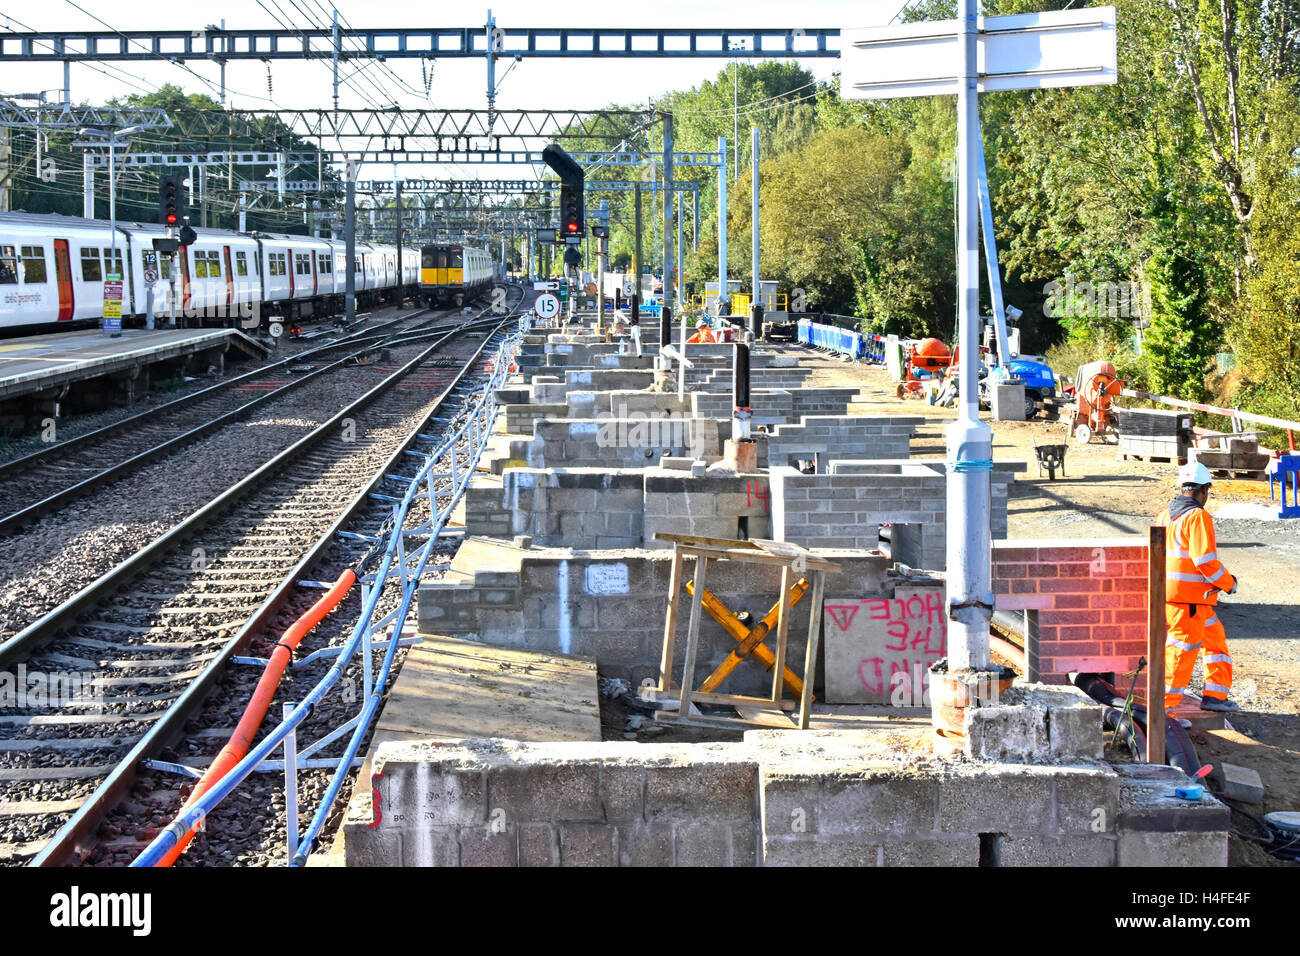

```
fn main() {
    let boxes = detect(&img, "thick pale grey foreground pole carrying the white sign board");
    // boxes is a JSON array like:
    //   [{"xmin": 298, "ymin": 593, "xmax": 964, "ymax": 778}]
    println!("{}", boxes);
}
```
[{"xmin": 946, "ymin": 0, "xmax": 993, "ymax": 674}]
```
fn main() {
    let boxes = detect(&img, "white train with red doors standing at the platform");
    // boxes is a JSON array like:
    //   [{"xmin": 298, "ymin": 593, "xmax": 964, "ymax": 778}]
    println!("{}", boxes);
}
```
[{"xmin": 0, "ymin": 212, "xmax": 420, "ymax": 336}]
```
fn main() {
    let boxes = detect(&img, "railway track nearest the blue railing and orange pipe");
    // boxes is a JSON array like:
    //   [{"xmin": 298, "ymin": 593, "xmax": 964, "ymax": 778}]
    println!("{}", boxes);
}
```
[{"xmin": 0, "ymin": 287, "xmax": 527, "ymax": 862}]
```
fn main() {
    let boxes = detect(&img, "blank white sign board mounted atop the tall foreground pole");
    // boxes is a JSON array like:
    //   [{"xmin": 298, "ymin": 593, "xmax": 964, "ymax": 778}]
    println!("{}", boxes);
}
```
[{"xmin": 840, "ymin": 7, "xmax": 1119, "ymax": 100}]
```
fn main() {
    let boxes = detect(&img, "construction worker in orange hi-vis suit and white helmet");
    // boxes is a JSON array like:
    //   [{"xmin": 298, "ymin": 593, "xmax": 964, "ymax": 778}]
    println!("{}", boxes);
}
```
[{"xmin": 1156, "ymin": 462, "xmax": 1238, "ymax": 713}]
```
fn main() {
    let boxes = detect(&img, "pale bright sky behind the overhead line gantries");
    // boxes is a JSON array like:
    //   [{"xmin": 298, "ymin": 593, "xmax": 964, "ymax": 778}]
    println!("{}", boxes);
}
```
[{"xmin": 0, "ymin": 0, "xmax": 904, "ymax": 178}]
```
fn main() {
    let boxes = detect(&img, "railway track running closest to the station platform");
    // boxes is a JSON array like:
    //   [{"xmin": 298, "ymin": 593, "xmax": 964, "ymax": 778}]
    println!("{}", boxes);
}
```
[{"xmin": 0, "ymin": 310, "xmax": 473, "ymax": 535}]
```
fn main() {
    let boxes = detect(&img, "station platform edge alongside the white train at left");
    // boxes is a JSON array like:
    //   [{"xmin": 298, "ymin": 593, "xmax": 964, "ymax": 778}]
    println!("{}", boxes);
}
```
[{"xmin": 0, "ymin": 329, "xmax": 268, "ymax": 402}]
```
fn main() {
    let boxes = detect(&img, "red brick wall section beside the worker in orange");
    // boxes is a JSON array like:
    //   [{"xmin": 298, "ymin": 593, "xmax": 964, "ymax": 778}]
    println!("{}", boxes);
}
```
[{"xmin": 993, "ymin": 537, "xmax": 1147, "ymax": 684}]
